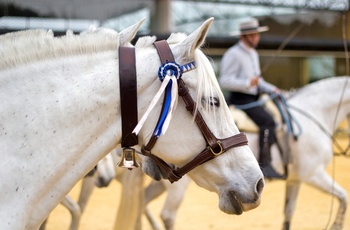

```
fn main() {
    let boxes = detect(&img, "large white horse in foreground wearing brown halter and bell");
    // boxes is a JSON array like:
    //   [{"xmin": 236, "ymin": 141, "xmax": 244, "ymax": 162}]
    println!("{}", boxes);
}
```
[{"xmin": 0, "ymin": 19, "xmax": 264, "ymax": 230}]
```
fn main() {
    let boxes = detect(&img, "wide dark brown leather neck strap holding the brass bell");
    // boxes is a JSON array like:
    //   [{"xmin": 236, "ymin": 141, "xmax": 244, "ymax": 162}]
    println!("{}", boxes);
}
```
[{"xmin": 119, "ymin": 47, "xmax": 138, "ymax": 147}]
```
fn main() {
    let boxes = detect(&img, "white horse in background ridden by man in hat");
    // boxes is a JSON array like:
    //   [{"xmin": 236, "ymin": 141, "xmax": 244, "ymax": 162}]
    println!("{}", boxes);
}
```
[{"xmin": 237, "ymin": 77, "xmax": 350, "ymax": 230}]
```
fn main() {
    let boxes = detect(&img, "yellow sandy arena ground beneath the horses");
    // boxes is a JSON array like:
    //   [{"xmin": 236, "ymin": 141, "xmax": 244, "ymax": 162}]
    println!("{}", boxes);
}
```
[{"xmin": 46, "ymin": 139, "xmax": 350, "ymax": 230}]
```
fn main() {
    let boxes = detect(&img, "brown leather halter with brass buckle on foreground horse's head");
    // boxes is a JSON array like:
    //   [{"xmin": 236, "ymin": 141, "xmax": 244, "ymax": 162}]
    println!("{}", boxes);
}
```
[{"xmin": 122, "ymin": 40, "xmax": 248, "ymax": 183}]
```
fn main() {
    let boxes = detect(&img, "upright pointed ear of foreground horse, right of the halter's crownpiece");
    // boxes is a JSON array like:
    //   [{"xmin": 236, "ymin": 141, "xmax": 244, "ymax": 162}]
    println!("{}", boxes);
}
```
[{"xmin": 173, "ymin": 17, "xmax": 214, "ymax": 59}]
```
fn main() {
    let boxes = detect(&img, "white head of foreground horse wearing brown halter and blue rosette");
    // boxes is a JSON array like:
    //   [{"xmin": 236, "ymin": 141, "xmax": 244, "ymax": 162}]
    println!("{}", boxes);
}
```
[{"xmin": 135, "ymin": 19, "xmax": 264, "ymax": 214}]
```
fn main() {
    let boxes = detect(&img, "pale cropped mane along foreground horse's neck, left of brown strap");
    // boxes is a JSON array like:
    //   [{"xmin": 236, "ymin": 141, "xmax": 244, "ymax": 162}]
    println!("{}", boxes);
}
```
[{"xmin": 0, "ymin": 29, "xmax": 119, "ymax": 69}]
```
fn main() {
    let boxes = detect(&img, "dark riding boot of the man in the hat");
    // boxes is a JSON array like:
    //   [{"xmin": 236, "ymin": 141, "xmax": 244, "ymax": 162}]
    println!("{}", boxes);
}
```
[{"xmin": 259, "ymin": 129, "xmax": 284, "ymax": 179}]
